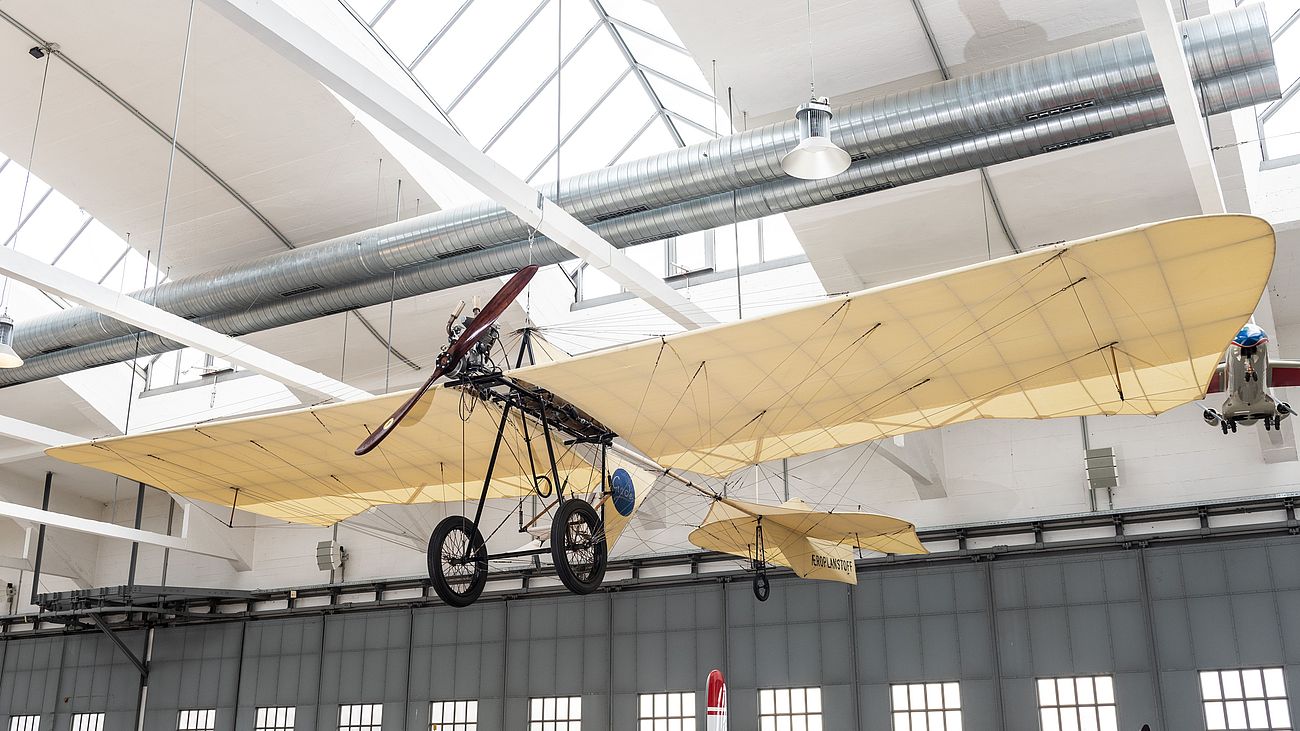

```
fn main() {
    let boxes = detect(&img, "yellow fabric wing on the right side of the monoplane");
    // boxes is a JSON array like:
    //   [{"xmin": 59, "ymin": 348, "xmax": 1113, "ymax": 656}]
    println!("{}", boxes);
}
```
[{"xmin": 514, "ymin": 216, "xmax": 1274, "ymax": 476}]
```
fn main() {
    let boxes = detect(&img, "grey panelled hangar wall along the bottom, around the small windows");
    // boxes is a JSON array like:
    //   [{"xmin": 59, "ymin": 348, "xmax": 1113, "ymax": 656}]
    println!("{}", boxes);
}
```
[{"xmin": 0, "ymin": 528, "xmax": 1300, "ymax": 731}]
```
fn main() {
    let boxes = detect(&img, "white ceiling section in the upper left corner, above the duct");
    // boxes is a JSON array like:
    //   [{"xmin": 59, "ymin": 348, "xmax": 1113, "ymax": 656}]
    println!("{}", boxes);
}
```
[{"xmin": 0, "ymin": 0, "xmax": 433, "ymax": 276}]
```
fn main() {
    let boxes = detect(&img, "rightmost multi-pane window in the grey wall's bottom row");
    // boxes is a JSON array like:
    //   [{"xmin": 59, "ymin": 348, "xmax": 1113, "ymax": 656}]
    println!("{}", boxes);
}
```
[{"xmin": 1201, "ymin": 667, "xmax": 1291, "ymax": 731}]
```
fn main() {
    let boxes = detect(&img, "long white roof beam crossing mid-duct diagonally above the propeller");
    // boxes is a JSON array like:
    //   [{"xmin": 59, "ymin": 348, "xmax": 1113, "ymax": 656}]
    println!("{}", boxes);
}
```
[{"xmin": 213, "ymin": 0, "xmax": 716, "ymax": 329}]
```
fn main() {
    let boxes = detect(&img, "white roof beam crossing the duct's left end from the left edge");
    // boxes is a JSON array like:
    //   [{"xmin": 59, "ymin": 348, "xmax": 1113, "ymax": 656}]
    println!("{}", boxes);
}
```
[{"xmin": 0, "ymin": 248, "xmax": 371, "ymax": 401}]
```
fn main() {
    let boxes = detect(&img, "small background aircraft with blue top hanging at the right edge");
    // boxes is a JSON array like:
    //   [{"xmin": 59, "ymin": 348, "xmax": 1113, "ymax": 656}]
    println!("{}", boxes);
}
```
[{"xmin": 1203, "ymin": 323, "xmax": 1300, "ymax": 434}]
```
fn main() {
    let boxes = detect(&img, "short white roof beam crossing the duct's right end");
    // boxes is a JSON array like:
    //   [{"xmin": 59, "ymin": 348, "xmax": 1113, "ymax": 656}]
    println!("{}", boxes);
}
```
[{"xmin": 1138, "ymin": 0, "xmax": 1227, "ymax": 213}]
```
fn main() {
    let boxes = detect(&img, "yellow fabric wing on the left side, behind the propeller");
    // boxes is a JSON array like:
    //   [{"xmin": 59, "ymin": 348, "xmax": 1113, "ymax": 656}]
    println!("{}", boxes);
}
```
[{"xmin": 47, "ymin": 388, "xmax": 595, "ymax": 525}]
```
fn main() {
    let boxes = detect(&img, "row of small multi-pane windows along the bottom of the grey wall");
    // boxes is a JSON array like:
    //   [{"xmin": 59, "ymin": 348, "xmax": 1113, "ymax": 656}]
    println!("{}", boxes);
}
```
[{"xmin": 9, "ymin": 667, "xmax": 1292, "ymax": 731}]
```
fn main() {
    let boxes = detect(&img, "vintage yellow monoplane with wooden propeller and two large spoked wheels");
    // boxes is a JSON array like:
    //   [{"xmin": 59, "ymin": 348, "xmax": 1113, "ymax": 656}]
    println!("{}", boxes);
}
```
[{"xmin": 48, "ymin": 216, "xmax": 1274, "ymax": 606}]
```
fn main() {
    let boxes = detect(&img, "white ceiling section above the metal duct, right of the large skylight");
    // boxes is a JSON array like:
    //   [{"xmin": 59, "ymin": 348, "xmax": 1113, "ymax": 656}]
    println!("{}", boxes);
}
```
[{"xmin": 658, "ymin": 0, "xmax": 1206, "ymax": 125}]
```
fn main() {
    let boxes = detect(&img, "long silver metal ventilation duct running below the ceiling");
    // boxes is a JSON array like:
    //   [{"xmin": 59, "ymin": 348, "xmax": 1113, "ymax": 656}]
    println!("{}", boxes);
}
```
[{"xmin": 0, "ymin": 5, "xmax": 1281, "ymax": 385}]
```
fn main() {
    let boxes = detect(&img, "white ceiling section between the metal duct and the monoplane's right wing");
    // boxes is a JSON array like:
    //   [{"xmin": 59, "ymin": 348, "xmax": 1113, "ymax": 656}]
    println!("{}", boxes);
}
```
[{"xmin": 787, "ymin": 127, "xmax": 1200, "ymax": 291}]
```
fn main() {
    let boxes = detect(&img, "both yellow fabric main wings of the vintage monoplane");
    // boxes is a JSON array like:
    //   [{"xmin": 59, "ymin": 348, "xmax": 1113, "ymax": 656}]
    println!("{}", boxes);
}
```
[{"xmin": 47, "ymin": 216, "xmax": 1274, "ymax": 524}]
